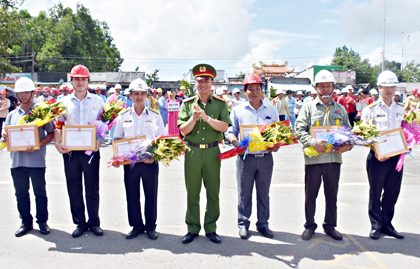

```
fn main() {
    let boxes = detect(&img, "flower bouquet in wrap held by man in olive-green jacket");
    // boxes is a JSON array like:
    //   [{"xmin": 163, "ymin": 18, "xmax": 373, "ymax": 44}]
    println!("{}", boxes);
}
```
[{"xmin": 303, "ymin": 119, "xmax": 381, "ymax": 158}]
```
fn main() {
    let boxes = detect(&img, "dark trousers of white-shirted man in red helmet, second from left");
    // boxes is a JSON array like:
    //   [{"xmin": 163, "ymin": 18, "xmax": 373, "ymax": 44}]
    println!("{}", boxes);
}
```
[{"xmin": 63, "ymin": 151, "xmax": 101, "ymax": 227}]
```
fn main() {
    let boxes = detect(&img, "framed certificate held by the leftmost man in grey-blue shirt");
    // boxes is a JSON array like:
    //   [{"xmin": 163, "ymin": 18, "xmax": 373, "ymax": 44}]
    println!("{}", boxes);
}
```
[{"xmin": 4, "ymin": 124, "xmax": 41, "ymax": 151}]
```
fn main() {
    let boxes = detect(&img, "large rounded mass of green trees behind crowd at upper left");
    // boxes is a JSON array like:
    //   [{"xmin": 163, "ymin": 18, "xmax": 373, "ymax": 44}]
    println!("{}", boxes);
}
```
[{"xmin": 11, "ymin": 2, "xmax": 123, "ymax": 72}]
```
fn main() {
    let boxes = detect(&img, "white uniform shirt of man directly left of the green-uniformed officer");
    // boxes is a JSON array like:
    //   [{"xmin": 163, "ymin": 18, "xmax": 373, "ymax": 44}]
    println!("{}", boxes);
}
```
[{"xmin": 114, "ymin": 107, "xmax": 166, "ymax": 140}]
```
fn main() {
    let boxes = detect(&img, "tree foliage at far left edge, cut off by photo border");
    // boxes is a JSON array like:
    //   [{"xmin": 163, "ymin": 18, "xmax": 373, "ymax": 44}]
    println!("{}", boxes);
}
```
[{"xmin": 0, "ymin": 0, "xmax": 22, "ymax": 77}]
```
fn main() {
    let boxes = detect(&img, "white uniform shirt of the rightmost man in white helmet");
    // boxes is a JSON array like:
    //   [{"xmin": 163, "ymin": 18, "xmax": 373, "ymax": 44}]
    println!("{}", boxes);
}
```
[{"xmin": 361, "ymin": 99, "xmax": 404, "ymax": 132}]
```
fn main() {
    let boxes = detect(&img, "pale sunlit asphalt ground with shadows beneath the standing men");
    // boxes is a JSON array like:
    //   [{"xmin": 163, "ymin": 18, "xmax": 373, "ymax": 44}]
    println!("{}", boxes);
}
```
[{"xmin": 0, "ymin": 141, "xmax": 420, "ymax": 268}]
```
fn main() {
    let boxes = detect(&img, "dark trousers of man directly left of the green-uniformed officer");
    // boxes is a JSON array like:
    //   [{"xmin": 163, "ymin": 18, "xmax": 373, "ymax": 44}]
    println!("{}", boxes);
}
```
[{"xmin": 124, "ymin": 162, "xmax": 159, "ymax": 232}]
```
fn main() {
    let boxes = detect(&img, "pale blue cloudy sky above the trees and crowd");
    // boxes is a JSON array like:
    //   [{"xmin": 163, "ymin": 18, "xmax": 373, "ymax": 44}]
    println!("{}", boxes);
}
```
[{"xmin": 21, "ymin": 0, "xmax": 420, "ymax": 80}]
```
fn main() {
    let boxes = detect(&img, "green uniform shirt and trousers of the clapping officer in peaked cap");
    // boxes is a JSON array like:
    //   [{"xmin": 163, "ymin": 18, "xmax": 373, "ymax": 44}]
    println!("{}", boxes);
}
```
[{"xmin": 178, "ymin": 95, "xmax": 231, "ymax": 234}]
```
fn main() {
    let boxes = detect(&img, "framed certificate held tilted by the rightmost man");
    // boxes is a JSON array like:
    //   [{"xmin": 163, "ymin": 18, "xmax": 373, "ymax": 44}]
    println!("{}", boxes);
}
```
[{"xmin": 373, "ymin": 128, "xmax": 408, "ymax": 159}]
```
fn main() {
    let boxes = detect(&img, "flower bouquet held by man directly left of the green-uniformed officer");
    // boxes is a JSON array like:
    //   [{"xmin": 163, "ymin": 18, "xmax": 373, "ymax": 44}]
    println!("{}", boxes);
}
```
[{"xmin": 107, "ymin": 135, "xmax": 185, "ymax": 168}]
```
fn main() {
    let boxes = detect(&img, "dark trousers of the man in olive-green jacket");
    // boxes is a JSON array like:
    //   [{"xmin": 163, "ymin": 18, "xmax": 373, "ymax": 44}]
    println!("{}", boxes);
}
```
[{"xmin": 305, "ymin": 163, "xmax": 341, "ymax": 231}]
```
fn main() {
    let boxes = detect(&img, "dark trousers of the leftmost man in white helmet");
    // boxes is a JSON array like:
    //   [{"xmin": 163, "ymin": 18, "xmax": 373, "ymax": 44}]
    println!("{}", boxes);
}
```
[{"xmin": 10, "ymin": 167, "xmax": 48, "ymax": 225}]
